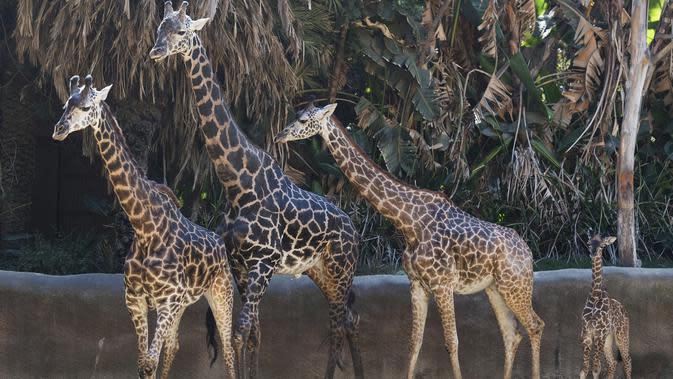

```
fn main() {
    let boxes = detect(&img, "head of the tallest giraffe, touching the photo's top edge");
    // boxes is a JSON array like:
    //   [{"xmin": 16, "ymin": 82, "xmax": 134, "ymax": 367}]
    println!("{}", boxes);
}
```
[{"xmin": 150, "ymin": 1, "xmax": 209, "ymax": 61}]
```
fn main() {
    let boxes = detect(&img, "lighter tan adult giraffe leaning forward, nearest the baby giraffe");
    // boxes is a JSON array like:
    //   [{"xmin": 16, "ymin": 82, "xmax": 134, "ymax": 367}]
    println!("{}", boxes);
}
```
[{"xmin": 275, "ymin": 104, "xmax": 544, "ymax": 379}]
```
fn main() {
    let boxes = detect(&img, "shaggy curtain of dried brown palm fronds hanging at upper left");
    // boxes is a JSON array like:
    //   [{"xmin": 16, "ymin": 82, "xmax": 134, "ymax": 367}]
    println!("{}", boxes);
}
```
[{"xmin": 14, "ymin": 0, "xmax": 302, "ymax": 186}]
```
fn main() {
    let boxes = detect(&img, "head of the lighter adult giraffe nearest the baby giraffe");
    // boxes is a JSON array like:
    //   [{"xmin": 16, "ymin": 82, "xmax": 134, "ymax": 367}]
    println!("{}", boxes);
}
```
[{"xmin": 274, "ymin": 104, "xmax": 336, "ymax": 143}]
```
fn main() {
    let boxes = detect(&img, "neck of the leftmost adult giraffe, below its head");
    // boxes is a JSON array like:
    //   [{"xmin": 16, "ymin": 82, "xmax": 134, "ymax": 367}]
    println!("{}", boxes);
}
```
[{"xmin": 94, "ymin": 102, "xmax": 150, "ymax": 234}]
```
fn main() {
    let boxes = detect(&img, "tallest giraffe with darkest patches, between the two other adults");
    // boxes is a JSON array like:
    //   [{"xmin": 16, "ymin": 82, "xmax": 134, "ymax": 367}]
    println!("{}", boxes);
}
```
[{"xmin": 149, "ymin": 1, "xmax": 363, "ymax": 378}]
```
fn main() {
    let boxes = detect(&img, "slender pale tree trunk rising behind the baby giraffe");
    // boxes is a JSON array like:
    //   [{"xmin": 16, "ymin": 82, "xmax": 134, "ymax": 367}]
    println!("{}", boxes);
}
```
[{"xmin": 617, "ymin": 0, "xmax": 650, "ymax": 267}]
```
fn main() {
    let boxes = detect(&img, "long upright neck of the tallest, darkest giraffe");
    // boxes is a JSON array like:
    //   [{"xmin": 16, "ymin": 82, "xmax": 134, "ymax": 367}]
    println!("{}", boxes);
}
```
[{"xmin": 184, "ymin": 35, "xmax": 265, "ymax": 198}]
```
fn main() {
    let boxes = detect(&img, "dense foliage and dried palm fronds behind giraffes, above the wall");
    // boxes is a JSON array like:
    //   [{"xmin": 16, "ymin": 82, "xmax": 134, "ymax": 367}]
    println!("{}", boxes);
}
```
[{"xmin": 1, "ymin": 0, "xmax": 673, "ymax": 271}]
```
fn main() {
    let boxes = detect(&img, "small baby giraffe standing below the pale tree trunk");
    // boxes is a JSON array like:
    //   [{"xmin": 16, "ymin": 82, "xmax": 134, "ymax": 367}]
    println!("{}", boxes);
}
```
[{"xmin": 580, "ymin": 234, "xmax": 631, "ymax": 379}]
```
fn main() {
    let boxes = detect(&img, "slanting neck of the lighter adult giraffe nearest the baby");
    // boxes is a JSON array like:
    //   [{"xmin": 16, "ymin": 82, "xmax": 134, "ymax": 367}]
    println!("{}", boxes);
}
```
[{"xmin": 321, "ymin": 117, "xmax": 438, "ymax": 237}]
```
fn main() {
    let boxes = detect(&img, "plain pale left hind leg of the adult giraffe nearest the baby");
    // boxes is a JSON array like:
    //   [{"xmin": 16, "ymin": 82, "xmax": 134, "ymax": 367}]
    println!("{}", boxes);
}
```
[{"xmin": 486, "ymin": 286, "xmax": 522, "ymax": 379}]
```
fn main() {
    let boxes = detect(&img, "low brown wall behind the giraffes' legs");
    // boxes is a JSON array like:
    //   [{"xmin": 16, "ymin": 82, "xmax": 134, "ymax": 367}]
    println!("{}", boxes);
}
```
[{"xmin": 0, "ymin": 267, "xmax": 673, "ymax": 378}]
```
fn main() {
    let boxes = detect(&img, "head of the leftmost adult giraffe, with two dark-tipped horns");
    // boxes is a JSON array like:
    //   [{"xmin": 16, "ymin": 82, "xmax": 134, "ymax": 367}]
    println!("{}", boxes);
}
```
[{"xmin": 52, "ymin": 75, "xmax": 112, "ymax": 141}]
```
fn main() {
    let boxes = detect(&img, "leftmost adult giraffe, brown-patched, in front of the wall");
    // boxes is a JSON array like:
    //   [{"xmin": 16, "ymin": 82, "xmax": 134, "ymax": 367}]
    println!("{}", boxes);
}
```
[{"xmin": 52, "ymin": 75, "xmax": 235, "ymax": 378}]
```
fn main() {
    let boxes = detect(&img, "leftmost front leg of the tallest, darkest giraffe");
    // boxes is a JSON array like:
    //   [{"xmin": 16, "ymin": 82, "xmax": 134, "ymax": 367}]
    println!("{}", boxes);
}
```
[{"xmin": 233, "ymin": 262, "xmax": 275, "ymax": 379}]
